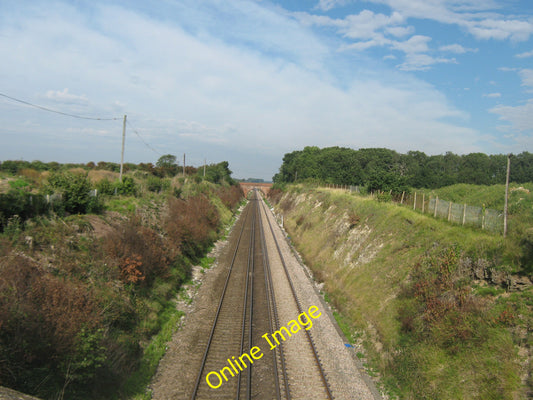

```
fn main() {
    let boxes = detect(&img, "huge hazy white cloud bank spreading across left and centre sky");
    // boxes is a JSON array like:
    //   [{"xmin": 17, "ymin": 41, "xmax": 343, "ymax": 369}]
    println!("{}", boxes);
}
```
[{"xmin": 0, "ymin": 0, "xmax": 504, "ymax": 178}]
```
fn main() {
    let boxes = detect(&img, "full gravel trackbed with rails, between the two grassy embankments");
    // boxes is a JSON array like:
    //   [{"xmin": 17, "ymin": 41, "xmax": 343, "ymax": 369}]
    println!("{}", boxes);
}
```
[{"xmin": 152, "ymin": 190, "xmax": 380, "ymax": 400}]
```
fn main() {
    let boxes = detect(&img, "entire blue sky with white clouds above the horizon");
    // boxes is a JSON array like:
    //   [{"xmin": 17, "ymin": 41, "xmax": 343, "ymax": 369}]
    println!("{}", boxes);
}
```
[{"xmin": 0, "ymin": 0, "xmax": 533, "ymax": 180}]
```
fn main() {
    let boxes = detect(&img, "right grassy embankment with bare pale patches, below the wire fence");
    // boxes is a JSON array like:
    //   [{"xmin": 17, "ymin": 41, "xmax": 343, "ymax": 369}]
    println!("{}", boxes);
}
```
[{"xmin": 272, "ymin": 187, "xmax": 533, "ymax": 399}]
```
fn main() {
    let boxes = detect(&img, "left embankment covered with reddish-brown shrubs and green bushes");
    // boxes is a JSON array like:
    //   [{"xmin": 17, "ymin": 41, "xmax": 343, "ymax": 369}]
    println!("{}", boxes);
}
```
[{"xmin": 0, "ymin": 170, "xmax": 242, "ymax": 399}]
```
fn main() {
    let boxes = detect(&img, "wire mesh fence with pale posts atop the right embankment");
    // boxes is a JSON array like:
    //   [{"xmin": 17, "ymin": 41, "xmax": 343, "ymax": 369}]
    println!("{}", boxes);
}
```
[{"xmin": 327, "ymin": 185, "xmax": 504, "ymax": 234}]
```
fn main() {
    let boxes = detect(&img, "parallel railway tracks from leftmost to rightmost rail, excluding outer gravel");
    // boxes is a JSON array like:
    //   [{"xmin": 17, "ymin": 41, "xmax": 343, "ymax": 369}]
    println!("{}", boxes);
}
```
[{"xmin": 189, "ymin": 191, "xmax": 333, "ymax": 400}]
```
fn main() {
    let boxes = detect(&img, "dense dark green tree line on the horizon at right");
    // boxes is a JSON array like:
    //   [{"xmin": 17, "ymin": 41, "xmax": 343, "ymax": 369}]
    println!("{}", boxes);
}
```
[{"xmin": 273, "ymin": 146, "xmax": 533, "ymax": 193}]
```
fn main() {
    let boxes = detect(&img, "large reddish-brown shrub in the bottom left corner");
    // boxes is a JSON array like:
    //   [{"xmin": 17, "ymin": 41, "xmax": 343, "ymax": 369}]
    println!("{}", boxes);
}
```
[{"xmin": 0, "ymin": 255, "xmax": 102, "ymax": 387}]
